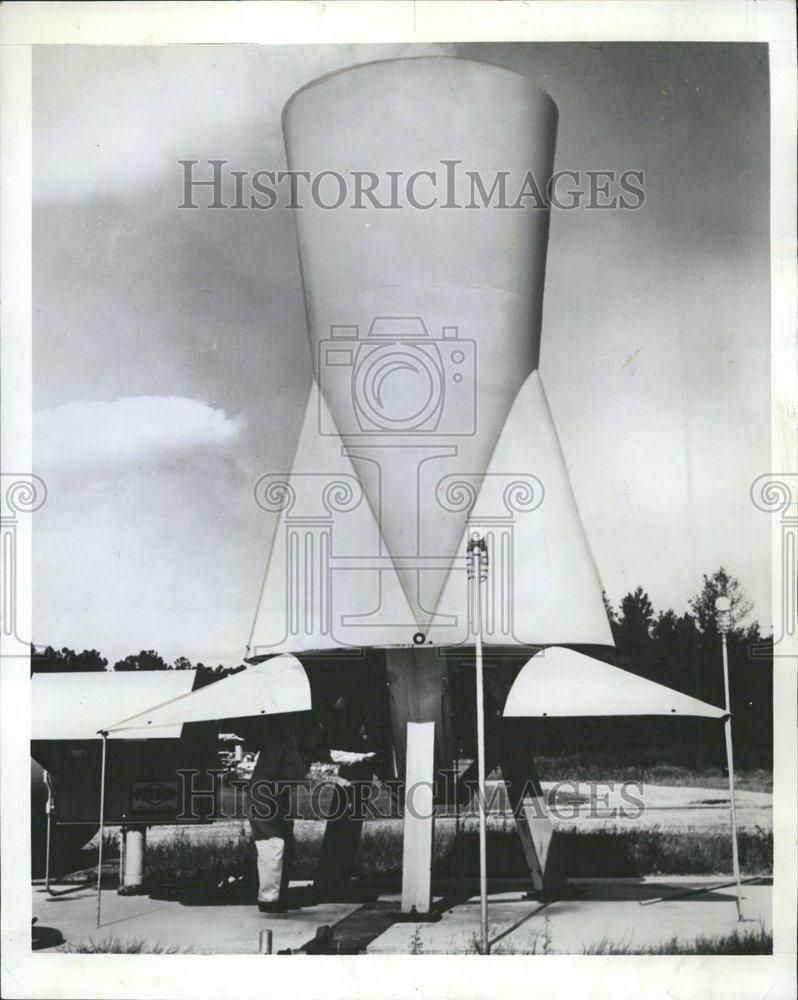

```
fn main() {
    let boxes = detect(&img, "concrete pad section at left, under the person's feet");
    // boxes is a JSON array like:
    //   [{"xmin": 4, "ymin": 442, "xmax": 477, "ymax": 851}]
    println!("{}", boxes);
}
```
[{"xmin": 33, "ymin": 886, "xmax": 361, "ymax": 955}]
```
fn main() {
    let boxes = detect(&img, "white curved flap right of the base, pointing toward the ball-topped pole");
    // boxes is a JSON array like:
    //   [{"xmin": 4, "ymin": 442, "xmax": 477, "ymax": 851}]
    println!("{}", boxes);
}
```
[{"xmin": 504, "ymin": 646, "xmax": 726, "ymax": 719}]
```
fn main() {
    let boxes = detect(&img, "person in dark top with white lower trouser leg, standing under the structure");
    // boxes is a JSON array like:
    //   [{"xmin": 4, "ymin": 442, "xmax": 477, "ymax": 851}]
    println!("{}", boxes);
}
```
[{"xmin": 249, "ymin": 712, "xmax": 374, "ymax": 913}]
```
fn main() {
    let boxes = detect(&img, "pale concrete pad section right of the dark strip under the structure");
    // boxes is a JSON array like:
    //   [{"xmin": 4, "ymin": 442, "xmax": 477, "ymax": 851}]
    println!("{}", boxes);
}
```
[{"xmin": 367, "ymin": 876, "xmax": 772, "ymax": 955}]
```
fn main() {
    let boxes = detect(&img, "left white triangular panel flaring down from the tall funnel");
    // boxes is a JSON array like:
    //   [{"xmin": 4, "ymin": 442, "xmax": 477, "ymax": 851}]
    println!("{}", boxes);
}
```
[{"xmin": 247, "ymin": 384, "xmax": 416, "ymax": 657}]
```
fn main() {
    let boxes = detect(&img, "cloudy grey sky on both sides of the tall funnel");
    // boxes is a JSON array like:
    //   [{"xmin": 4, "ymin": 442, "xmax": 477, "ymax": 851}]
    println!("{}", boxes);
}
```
[{"xmin": 33, "ymin": 43, "xmax": 770, "ymax": 664}]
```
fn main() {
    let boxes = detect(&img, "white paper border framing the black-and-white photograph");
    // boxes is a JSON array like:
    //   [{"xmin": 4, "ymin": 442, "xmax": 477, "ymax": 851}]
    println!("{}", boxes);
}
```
[{"xmin": 0, "ymin": 0, "xmax": 798, "ymax": 1000}]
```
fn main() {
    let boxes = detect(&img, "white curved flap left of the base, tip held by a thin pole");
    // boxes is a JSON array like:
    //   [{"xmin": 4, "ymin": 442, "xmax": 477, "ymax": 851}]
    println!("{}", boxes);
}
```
[{"xmin": 101, "ymin": 654, "xmax": 311, "ymax": 737}]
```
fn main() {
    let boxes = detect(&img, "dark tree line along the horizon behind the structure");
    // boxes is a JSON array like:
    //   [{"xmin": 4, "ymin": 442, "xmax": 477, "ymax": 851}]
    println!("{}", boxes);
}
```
[{"xmin": 31, "ymin": 567, "xmax": 773, "ymax": 768}]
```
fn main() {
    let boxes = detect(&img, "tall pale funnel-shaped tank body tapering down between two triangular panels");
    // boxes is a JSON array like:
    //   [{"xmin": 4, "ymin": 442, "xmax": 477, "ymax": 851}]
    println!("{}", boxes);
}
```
[{"xmin": 284, "ymin": 58, "xmax": 557, "ymax": 606}]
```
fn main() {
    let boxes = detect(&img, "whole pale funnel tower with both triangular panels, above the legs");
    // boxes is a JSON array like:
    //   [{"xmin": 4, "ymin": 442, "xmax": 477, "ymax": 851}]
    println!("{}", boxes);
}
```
[{"xmin": 248, "ymin": 57, "xmax": 612, "ymax": 657}]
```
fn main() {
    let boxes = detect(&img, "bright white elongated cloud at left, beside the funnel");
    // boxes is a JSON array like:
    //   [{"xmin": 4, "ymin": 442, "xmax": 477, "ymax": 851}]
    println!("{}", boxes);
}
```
[{"xmin": 33, "ymin": 396, "xmax": 246, "ymax": 472}]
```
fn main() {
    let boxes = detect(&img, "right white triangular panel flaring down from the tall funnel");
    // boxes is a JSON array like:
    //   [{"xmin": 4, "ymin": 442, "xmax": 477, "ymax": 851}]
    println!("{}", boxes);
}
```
[{"xmin": 430, "ymin": 372, "xmax": 613, "ymax": 646}]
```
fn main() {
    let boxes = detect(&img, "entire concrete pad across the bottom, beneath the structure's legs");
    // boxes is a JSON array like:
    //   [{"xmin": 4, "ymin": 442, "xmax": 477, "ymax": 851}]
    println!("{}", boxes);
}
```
[{"xmin": 33, "ymin": 877, "xmax": 771, "ymax": 954}]
